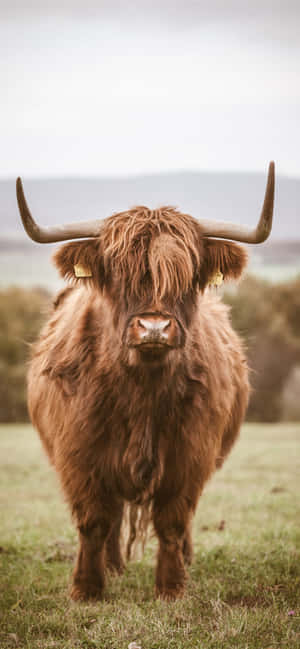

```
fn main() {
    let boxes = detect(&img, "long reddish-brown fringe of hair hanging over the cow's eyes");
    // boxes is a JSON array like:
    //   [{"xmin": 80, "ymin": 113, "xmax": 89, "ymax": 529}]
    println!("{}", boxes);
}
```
[{"xmin": 101, "ymin": 206, "xmax": 200, "ymax": 300}]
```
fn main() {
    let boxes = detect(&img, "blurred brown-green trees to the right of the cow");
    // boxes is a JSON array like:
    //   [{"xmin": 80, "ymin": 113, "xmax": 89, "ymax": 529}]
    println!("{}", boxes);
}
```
[{"xmin": 224, "ymin": 276, "xmax": 300, "ymax": 422}]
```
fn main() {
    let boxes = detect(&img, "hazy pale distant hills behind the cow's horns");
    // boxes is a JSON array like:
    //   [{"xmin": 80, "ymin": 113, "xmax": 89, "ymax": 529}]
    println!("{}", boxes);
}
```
[{"xmin": 0, "ymin": 172, "xmax": 300, "ymax": 288}]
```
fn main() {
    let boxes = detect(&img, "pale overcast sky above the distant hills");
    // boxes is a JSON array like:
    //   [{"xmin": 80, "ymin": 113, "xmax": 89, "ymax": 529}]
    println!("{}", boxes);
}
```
[{"xmin": 0, "ymin": 0, "xmax": 300, "ymax": 178}]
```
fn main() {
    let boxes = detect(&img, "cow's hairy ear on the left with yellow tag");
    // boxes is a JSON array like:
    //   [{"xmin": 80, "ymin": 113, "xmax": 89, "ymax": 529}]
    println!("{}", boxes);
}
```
[{"xmin": 53, "ymin": 239, "xmax": 104, "ymax": 288}]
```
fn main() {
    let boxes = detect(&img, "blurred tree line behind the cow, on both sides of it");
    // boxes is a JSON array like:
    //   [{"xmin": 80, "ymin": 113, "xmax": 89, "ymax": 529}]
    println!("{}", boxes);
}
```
[{"xmin": 0, "ymin": 276, "xmax": 300, "ymax": 422}]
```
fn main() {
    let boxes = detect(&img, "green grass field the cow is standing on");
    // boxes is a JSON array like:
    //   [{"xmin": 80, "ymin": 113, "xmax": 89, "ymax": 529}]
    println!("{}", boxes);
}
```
[{"xmin": 0, "ymin": 424, "xmax": 300, "ymax": 649}]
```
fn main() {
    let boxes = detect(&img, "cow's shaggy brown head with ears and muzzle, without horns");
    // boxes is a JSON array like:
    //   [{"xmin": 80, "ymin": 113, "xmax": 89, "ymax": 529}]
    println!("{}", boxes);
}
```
[{"xmin": 55, "ymin": 207, "xmax": 246, "ymax": 366}]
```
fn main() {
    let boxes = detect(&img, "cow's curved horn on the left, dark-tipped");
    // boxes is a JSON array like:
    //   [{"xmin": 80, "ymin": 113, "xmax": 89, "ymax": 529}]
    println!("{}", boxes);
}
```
[{"xmin": 17, "ymin": 178, "xmax": 101, "ymax": 243}]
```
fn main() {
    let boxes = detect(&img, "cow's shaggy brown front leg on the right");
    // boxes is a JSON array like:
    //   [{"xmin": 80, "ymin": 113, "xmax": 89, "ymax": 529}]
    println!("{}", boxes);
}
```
[{"xmin": 153, "ymin": 499, "xmax": 191, "ymax": 600}]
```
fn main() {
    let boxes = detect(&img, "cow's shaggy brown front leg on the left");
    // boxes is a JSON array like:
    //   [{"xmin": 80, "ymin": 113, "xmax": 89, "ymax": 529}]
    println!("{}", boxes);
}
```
[{"xmin": 71, "ymin": 502, "xmax": 116, "ymax": 600}]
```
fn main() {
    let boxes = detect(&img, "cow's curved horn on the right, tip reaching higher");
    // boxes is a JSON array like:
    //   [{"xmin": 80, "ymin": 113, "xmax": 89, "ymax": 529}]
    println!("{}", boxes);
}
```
[{"xmin": 200, "ymin": 162, "xmax": 275, "ymax": 243}]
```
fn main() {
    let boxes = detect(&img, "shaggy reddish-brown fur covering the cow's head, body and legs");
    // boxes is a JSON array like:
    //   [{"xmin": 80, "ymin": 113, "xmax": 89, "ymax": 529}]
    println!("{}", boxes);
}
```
[{"xmin": 28, "ymin": 207, "xmax": 248, "ymax": 599}]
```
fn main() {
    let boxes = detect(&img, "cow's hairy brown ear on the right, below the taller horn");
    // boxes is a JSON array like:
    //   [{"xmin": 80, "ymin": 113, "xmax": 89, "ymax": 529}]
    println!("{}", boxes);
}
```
[{"xmin": 200, "ymin": 238, "xmax": 248, "ymax": 288}]
